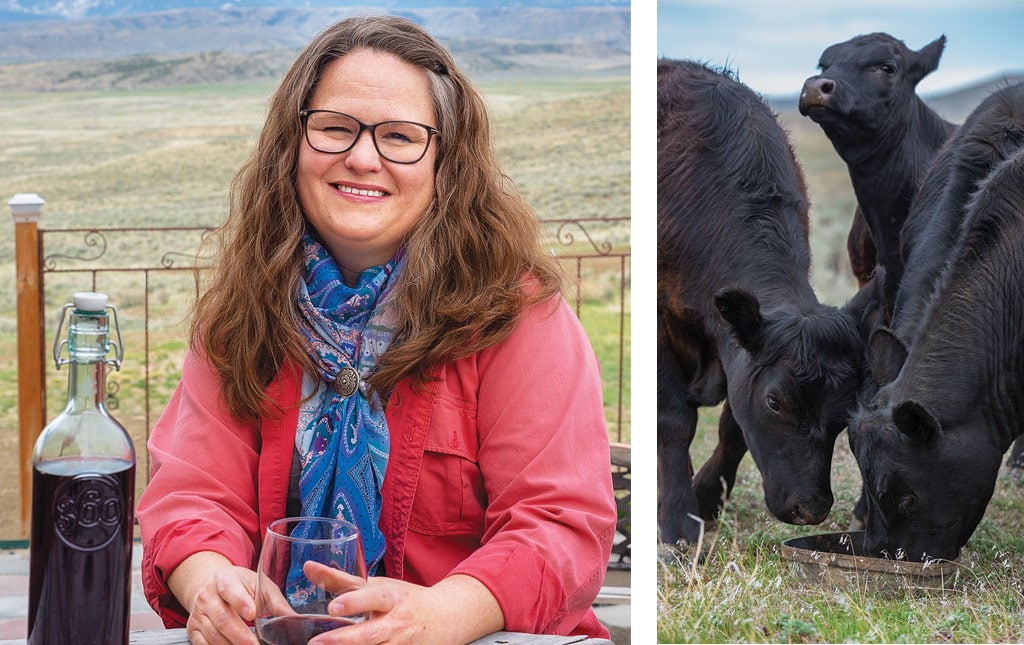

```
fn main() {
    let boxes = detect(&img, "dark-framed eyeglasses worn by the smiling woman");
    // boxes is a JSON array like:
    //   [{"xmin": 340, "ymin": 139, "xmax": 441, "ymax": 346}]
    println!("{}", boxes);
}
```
[{"xmin": 299, "ymin": 110, "xmax": 441, "ymax": 164}]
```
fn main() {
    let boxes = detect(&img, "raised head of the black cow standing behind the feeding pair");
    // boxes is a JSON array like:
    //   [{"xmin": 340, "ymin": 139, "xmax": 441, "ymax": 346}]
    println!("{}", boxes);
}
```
[{"xmin": 800, "ymin": 33, "xmax": 946, "ymax": 156}]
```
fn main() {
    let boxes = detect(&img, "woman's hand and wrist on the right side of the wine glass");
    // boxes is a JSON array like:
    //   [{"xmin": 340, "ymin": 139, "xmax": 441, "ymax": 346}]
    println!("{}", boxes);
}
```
[{"xmin": 306, "ymin": 563, "xmax": 505, "ymax": 645}]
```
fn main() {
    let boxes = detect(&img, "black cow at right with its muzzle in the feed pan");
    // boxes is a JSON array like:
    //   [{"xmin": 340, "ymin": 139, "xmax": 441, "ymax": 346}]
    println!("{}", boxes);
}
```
[{"xmin": 849, "ymin": 84, "xmax": 1024, "ymax": 560}]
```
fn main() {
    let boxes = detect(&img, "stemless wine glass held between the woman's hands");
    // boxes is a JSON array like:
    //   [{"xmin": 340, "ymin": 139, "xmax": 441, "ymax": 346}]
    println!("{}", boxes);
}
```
[{"xmin": 256, "ymin": 517, "xmax": 367, "ymax": 645}]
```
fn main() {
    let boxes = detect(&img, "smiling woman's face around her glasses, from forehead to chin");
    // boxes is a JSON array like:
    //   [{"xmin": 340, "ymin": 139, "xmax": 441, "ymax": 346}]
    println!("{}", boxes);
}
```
[{"xmin": 296, "ymin": 49, "xmax": 437, "ymax": 284}]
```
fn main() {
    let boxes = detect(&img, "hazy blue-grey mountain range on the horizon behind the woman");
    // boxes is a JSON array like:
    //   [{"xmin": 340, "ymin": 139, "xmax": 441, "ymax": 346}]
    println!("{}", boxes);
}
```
[{"xmin": 0, "ymin": 0, "xmax": 630, "ymax": 66}]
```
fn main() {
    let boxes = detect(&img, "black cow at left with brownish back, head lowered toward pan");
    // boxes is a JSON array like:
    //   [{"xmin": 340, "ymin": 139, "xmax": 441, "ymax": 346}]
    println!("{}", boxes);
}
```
[{"xmin": 657, "ymin": 59, "xmax": 864, "ymax": 544}]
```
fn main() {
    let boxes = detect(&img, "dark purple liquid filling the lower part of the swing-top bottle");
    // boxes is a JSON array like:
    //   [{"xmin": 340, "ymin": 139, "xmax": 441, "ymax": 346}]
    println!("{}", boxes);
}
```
[{"xmin": 28, "ymin": 458, "xmax": 135, "ymax": 645}]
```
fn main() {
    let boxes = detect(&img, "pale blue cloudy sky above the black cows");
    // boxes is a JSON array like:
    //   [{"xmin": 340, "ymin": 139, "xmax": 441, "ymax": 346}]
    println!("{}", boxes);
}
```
[{"xmin": 655, "ymin": 0, "xmax": 1024, "ymax": 95}]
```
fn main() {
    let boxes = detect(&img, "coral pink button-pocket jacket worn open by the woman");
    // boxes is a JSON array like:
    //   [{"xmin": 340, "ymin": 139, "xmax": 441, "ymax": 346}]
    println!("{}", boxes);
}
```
[{"xmin": 137, "ymin": 298, "xmax": 615, "ymax": 638}]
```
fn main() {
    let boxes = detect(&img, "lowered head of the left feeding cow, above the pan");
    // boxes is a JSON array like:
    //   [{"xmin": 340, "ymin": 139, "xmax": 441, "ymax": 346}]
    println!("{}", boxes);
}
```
[{"xmin": 715, "ymin": 289, "xmax": 864, "ymax": 524}]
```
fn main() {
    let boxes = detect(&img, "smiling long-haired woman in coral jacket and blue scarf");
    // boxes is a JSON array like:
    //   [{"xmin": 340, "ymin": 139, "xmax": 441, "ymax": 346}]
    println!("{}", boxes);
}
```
[{"xmin": 138, "ymin": 16, "xmax": 615, "ymax": 643}]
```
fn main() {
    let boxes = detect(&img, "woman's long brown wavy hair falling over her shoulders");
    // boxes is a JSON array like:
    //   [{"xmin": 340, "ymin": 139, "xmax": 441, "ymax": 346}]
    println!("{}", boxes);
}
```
[{"xmin": 191, "ymin": 16, "xmax": 560, "ymax": 420}]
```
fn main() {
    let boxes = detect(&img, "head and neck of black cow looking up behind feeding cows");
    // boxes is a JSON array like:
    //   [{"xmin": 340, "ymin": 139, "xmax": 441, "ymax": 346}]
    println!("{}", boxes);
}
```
[{"xmin": 800, "ymin": 33, "xmax": 955, "ymax": 307}]
